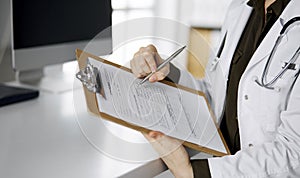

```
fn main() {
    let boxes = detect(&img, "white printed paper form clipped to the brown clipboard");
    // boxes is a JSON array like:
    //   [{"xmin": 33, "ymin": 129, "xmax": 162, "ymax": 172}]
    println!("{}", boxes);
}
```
[{"xmin": 89, "ymin": 58, "xmax": 226, "ymax": 153}]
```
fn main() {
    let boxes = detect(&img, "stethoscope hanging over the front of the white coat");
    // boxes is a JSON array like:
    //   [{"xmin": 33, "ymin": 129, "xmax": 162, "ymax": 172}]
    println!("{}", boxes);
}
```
[{"xmin": 255, "ymin": 16, "xmax": 300, "ymax": 90}]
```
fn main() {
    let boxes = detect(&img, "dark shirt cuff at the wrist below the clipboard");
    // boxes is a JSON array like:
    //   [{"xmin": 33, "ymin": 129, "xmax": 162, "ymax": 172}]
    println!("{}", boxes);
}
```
[{"xmin": 191, "ymin": 159, "xmax": 211, "ymax": 178}]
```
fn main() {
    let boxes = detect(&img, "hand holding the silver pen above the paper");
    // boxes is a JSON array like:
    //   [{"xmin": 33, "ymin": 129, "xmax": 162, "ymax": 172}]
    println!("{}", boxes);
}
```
[{"xmin": 130, "ymin": 45, "xmax": 170, "ymax": 82}]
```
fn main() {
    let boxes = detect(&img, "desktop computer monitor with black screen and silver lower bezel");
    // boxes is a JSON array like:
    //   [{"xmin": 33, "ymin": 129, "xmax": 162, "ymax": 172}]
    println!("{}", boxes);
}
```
[{"xmin": 10, "ymin": 0, "xmax": 112, "ymax": 80}]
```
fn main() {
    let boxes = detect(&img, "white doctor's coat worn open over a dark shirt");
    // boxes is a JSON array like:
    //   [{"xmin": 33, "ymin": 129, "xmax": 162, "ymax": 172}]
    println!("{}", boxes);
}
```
[{"xmin": 179, "ymin": 0, "xmax": 300, "ymax": 178}]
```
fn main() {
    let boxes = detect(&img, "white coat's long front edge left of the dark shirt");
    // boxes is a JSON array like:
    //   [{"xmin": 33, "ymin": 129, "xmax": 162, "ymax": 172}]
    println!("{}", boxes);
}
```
[{"xmin": 212, "ymin": 0, "xmax": 252, "ymax": 122}]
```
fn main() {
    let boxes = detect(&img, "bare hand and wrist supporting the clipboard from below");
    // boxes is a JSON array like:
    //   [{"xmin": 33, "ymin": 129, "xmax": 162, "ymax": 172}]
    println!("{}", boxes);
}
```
[{"xmin": 142, "ymin": 131, "xmax": 193, "ymax": 178}]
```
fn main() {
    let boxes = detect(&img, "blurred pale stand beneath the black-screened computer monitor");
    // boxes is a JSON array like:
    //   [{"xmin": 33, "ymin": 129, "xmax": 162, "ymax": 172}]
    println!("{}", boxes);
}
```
[{"xmin": 17, "ymin": 61, "xmax": 80, "ymax": 93}]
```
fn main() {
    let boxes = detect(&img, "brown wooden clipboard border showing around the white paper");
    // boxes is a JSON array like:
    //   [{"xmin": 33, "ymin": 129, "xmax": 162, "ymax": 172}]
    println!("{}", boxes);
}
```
[{"xmin": 75, "ymin": 49, "xmax": 230, "ymax": 156}]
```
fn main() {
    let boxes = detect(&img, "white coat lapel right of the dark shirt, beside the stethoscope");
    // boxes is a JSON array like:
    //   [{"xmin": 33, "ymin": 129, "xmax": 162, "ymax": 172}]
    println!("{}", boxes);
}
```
[{"xmin": 245, "ymin": 0, "xmax": 300, "ymax": 72}]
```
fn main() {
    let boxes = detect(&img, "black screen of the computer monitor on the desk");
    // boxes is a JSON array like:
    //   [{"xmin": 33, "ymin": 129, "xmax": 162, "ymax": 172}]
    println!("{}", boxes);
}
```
[{"xmin": 12, "ymin": 0, "xmax": 112, "ymax": 49}]
